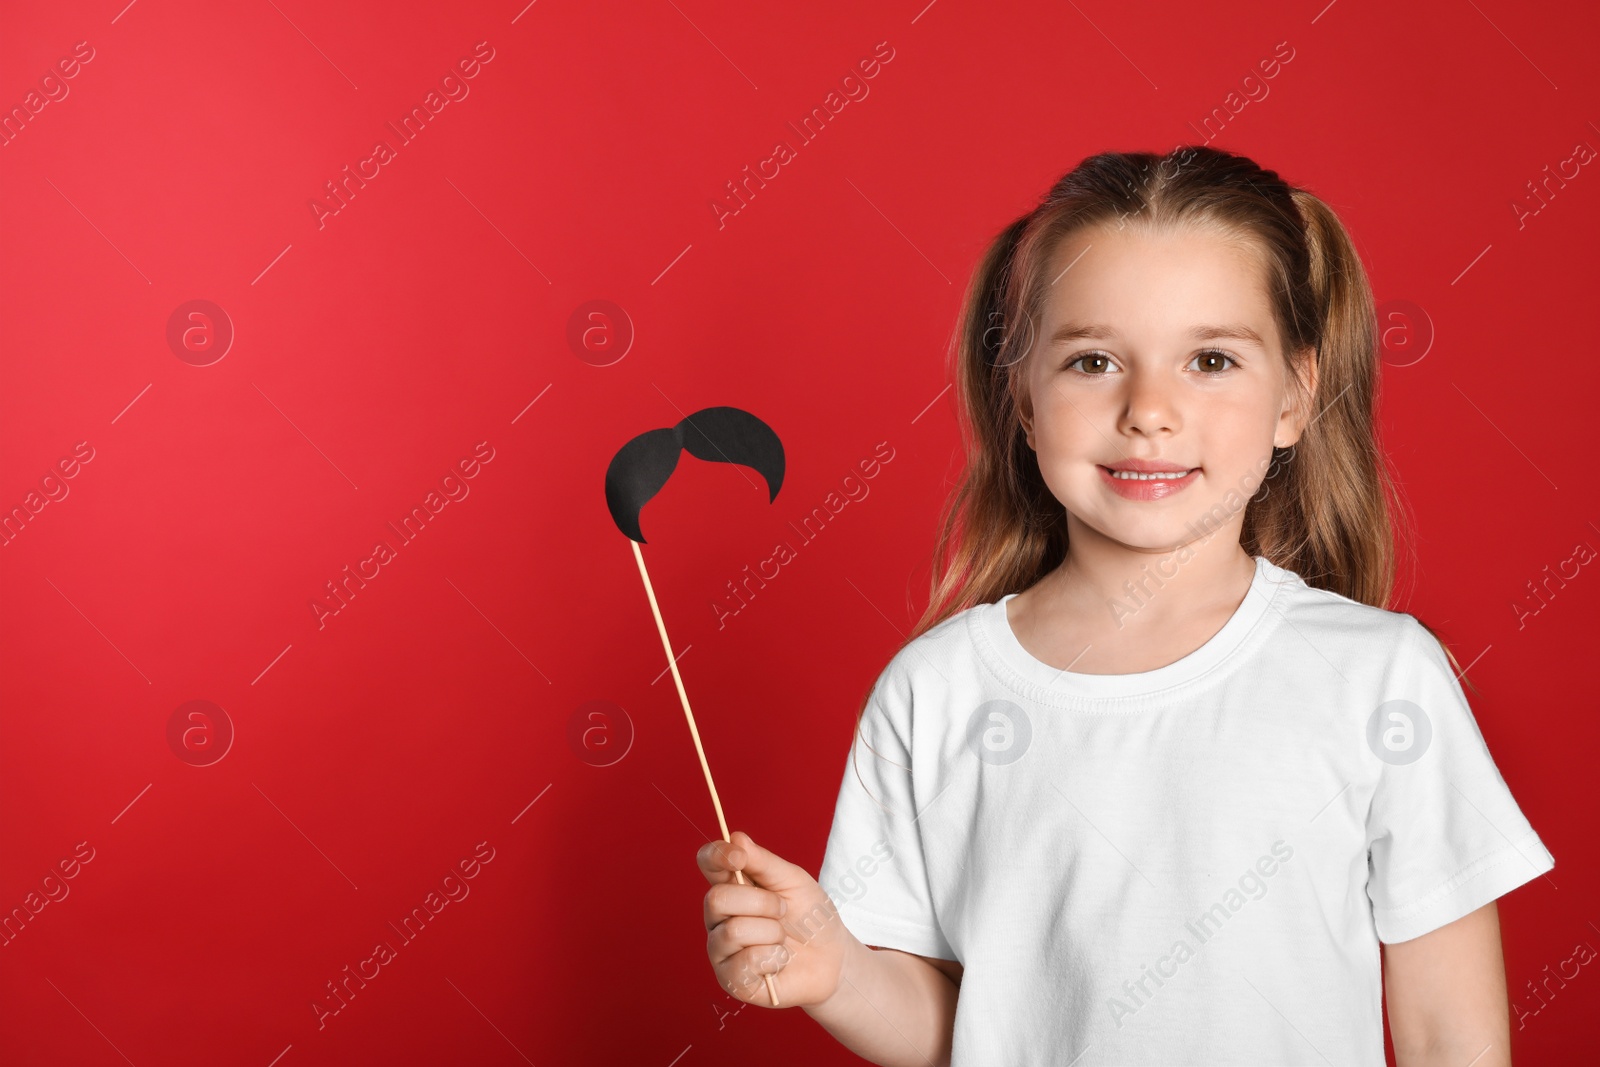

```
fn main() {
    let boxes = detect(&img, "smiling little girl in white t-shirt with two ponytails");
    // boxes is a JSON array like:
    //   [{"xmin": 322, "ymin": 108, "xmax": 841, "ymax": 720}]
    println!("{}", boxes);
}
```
[{"xmin": 698, "ymin": 147, "xmax": 1555, "ymax": 1067}]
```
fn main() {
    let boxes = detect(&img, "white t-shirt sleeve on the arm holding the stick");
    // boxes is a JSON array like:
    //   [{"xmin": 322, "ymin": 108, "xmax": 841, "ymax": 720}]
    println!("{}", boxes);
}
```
[{"xmin": 818, "ymin": 664, "xmax": 957, "ymax": 960}]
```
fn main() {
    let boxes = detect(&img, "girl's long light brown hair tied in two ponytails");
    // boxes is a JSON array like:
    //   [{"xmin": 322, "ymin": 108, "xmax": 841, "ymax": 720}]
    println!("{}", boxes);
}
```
[{"xmin": 876, "ymin": 146, "xmax": 1454, "ymax": 700}]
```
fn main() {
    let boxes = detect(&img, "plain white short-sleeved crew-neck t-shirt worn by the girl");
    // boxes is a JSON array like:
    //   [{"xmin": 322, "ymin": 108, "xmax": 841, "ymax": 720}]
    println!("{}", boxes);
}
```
[{"xmin": 819, "ymin": 557, "xmax": 1555, "ymax": 1067}]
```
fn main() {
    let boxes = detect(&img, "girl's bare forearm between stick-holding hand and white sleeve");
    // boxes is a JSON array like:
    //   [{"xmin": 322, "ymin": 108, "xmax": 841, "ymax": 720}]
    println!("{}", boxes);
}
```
[{"xmin": 805, "ymin": 936, "xmax": 953, "ymax": 1067}]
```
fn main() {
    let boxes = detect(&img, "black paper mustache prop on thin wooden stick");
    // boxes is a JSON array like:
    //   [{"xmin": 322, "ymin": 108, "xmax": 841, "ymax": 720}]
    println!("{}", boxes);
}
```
[{"xmin": 605, "ymin": 408, "xmax": 784, "ymax": 1008}]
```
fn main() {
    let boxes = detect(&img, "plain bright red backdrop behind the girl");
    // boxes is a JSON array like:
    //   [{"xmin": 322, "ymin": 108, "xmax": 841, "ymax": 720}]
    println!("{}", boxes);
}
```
[{"xmin": 0, "ymin": 0, "xmax": 1600, "ymax": 1067}]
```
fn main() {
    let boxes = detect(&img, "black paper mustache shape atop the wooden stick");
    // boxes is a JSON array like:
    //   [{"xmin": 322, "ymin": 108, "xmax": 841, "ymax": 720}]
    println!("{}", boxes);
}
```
[{"xmin": 605, "ymin": 408, "xmax": 784, "ymax": 544}]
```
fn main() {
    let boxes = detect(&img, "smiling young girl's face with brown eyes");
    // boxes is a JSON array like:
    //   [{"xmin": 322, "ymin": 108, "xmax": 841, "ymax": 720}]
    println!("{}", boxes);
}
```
[{"xmin": 1022, "ymin": 226, "xmax": 1314, "ymax": 552}]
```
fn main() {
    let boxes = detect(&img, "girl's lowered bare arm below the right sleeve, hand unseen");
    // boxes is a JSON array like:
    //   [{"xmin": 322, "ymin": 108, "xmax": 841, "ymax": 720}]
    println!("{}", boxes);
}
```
[{"xmin": 1384, "ymin": 901, "xmax": 1510, "ymax": 1067}]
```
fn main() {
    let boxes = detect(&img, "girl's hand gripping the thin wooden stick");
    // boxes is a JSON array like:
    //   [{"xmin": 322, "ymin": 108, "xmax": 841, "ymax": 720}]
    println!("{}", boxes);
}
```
[{"xmin": 696, "ymin": 830, "xmax": 853, "ymax": 1008}]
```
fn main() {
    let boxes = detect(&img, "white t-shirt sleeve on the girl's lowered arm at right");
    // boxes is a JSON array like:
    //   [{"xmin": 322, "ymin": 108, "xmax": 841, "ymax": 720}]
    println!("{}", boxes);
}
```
[{"xmin": 1366, "ymin": 616, "xmax": 1555, "ymax": 944}]
